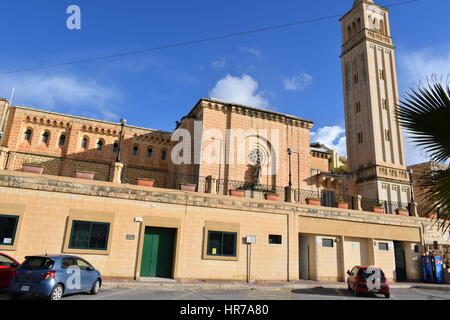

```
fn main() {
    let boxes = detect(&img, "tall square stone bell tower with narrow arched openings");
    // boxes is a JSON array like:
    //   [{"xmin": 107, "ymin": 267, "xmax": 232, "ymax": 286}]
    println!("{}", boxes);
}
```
[{"xmin": 340, "ymin": 0, "xmax": 410, "ymax": 203}]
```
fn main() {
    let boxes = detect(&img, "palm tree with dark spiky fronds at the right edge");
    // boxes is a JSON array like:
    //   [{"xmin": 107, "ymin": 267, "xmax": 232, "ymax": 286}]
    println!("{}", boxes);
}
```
[{"xmin": 396, "ymin": 79, "xmax": 450, "ymax": 231}]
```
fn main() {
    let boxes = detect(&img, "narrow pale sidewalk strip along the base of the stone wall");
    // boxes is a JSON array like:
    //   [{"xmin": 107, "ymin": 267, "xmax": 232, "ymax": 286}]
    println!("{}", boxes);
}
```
[{"xmin": 102, "ymin": 279, "xmax": 450, "ymax": 291}]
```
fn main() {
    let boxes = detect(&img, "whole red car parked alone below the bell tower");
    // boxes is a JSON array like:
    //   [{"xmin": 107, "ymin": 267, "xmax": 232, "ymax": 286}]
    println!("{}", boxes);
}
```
[{"xmin": 347, "ymin": 266, "xmax": 391, "ymax": 298}]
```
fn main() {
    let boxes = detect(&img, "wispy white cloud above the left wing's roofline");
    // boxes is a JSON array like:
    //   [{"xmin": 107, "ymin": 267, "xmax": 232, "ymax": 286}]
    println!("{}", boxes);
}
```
[{"xmin": 0, "ymin": 73, "xmax": 122, "ymax": 120}]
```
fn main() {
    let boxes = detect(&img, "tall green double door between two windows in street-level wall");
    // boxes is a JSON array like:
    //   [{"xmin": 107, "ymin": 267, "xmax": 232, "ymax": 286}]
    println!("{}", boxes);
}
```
[{"xmin": 141, "ymin": 227, "xmax": 176, "ymax": 278}]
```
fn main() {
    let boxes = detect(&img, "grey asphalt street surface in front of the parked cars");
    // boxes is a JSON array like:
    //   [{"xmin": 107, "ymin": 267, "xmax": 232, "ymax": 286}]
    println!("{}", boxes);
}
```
[{"xmin": 0, "ymin": 288, "xmax": 450, "ymax": 300}]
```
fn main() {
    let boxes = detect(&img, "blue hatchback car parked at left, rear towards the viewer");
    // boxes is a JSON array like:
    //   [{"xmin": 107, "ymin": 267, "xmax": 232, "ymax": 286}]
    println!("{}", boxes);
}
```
[{"xmin": 8, "ymin": 255, "xmax": 102, "ymax": 300}]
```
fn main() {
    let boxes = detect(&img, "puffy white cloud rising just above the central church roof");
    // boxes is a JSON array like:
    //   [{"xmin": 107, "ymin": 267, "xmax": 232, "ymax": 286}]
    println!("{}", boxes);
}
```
[{"xmin": 209, "ymin": 74, "xmax": 269, "ymax": 108}]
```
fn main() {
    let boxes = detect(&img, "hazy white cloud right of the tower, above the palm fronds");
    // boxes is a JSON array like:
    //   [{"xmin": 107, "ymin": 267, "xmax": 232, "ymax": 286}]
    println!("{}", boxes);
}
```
[{"xmin": 399, "ymin": 48, "xmax": 450, "ymax": 87}]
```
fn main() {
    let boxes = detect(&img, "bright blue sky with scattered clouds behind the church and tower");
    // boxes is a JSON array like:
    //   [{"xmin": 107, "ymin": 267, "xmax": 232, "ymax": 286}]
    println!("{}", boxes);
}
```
[{"xmin": 0, "ymin": 0, "xmax": 450, "ymax": 163}]
